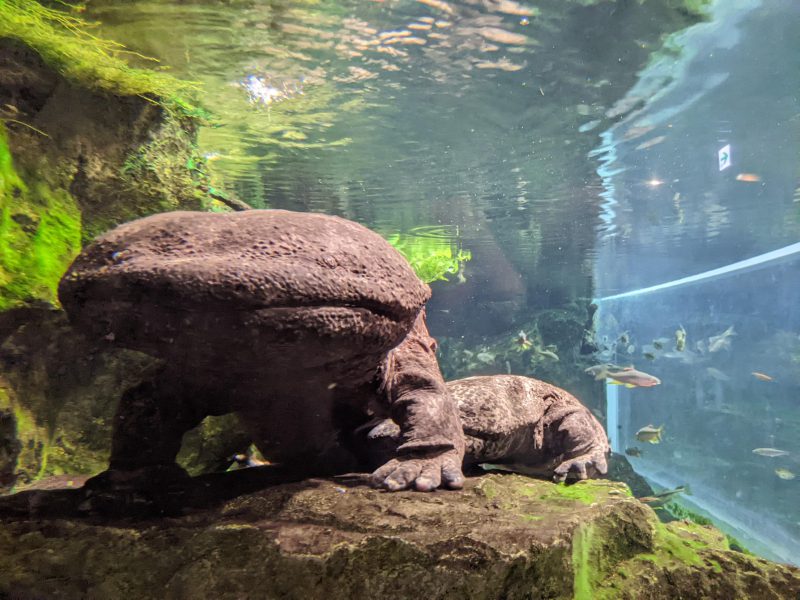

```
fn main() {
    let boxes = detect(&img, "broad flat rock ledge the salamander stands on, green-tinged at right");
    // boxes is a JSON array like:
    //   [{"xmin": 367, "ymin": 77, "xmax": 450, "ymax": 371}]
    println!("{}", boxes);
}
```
[{"xmin": 0, "ymin": 475, "xmax": 800, "ymax": 600}]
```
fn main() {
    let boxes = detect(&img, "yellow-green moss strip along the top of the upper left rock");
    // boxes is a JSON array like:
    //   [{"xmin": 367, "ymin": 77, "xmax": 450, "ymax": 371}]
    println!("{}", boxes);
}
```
[{"xmin": 0, "ymin": 0, "xmax": 197, "ymax": 105}]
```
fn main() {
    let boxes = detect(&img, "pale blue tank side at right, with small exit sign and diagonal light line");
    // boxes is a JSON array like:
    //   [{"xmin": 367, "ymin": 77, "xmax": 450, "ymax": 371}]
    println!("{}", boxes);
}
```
[{"xmin": 595, "ymin": 2, "xmax": 800, "ymax": 563}]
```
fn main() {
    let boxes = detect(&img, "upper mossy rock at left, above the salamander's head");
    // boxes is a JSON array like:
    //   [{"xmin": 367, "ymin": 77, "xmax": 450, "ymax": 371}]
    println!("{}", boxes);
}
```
[{"xmin": 0, "ymin": 0, "xmax": 211, "ymax": 310}]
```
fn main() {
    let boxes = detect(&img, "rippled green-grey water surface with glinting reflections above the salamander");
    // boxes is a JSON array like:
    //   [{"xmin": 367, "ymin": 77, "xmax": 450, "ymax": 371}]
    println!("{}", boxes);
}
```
[{"xmin": 84, "ymin": 0, "xmax": 700, "ymax": 328}]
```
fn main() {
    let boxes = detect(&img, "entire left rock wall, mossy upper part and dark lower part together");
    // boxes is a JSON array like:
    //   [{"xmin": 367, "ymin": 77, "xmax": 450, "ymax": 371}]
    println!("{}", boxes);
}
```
[{"xmin": 0, "ymin": 0, "xmax": 222, "ymax": 482}]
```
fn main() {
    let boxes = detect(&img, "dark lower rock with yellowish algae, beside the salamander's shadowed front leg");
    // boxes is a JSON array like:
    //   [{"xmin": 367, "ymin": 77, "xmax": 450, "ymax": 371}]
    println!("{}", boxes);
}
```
[{"xmin": 0, "ymin": 308, "xmax": 156, "ymax": 490}]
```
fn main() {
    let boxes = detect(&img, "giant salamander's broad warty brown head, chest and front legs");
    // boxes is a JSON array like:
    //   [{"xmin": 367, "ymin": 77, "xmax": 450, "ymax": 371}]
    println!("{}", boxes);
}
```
[{"xmin": 59, "ymin": 210, "xmax": 464, "ymax": 490}]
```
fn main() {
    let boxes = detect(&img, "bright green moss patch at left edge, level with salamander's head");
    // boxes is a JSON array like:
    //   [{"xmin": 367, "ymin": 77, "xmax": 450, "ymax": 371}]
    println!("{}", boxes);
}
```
[{"xmin": 0, "ymin": 122, "xmax": 81, "ymax": 310}]
